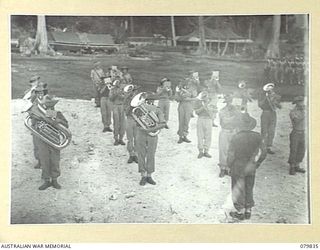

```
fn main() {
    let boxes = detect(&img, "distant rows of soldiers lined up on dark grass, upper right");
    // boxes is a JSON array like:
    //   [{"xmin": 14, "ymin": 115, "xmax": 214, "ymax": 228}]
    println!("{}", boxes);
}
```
[{"xmin": 264, "ymin": 57, "xmax": 308, "ymax": 85}]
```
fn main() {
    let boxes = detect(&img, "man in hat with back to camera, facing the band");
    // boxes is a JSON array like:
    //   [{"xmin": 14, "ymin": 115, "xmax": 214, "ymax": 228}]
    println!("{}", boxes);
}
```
[{"xmin": 227, "ymin": 113, "xmax": 267, "ymax": 220}]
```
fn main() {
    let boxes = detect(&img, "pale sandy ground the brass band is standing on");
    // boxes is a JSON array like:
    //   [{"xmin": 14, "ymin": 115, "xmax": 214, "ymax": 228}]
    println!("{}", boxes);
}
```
[{"xmin": 11, "ymin": 99, "xmax": 308, "ymax": 224}]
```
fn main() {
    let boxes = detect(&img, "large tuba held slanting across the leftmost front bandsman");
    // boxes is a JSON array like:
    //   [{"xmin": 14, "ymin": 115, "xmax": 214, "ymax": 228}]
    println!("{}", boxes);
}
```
[{"xmin": 24, "ymin": 100, "xmax": 72, "ymax": 150}]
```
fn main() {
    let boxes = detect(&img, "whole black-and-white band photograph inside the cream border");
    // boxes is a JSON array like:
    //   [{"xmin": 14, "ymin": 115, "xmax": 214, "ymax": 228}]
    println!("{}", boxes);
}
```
[{"xmin": 8, "ymin": 13, "xmax": 313, "ymax": 225}]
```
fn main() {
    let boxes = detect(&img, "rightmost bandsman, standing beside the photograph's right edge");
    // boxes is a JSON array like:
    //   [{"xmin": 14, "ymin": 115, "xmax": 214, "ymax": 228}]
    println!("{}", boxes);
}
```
[{"xmin": 288, "ymin": 96, "xmax": 306, "ymax": 175}]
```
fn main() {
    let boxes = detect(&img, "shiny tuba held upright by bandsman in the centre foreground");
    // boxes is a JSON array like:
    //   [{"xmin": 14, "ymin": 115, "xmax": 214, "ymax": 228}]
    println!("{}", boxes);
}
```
[{"xmin": 130, "ymin": 92, "xmax": 160, "ymax": 136}]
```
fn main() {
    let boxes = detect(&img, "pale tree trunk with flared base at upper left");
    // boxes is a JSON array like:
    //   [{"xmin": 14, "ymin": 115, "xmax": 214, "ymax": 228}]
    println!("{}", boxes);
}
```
[{"xmin": 34, "ymin": 15, "xmax": 48, "ymax": 54}]
